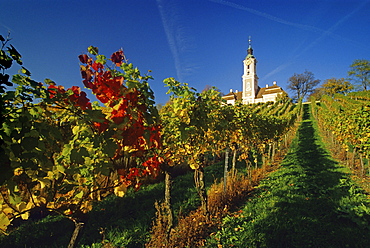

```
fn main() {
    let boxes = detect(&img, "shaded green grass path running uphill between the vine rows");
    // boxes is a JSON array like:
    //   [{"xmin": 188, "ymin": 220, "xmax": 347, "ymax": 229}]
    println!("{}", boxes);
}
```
[{"xmin": 209, "ymin": 105, "xmax": 370, "ymax": 247}]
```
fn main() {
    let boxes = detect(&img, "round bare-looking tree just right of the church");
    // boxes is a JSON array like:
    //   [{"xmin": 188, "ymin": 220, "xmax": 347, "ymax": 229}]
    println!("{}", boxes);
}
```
[{"xmin": 288, "ymin": 70, "xmax": 320, "ymax": 100}]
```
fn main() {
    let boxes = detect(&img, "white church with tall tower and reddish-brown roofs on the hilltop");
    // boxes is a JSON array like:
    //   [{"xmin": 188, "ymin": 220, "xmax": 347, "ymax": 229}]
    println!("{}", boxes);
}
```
[{"xmin": 222, "ymin": 38, "xmax": 284, "ymax": 105}]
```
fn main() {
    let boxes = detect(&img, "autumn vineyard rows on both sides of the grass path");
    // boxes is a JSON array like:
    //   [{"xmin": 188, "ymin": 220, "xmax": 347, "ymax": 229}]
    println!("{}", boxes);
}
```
[{"xmin": 0, "ymin": 36, "xmax": 370, "ymax": 247}]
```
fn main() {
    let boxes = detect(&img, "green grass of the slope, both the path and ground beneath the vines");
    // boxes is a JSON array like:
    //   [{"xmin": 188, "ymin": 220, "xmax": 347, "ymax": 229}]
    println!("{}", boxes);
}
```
[{"xmin": 0, "ymin": 105, "xmax": 370, "ymax": 247}]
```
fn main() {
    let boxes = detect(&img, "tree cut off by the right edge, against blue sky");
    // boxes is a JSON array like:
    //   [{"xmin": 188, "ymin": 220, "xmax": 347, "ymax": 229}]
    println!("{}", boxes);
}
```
[{"xmin": 348, "ymin": 59, "xmax": 370, "ymax": 90}]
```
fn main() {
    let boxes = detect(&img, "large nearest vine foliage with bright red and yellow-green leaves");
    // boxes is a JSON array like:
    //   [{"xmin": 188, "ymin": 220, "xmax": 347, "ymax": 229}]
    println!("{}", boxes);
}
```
[{"xmin": 0, "ymin": 39, "xmax": 161, "ymax": 233}]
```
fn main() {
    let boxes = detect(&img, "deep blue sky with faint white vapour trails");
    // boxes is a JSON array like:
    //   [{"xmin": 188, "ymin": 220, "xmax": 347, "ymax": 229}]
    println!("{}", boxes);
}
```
[{"xmin": 0, "ymin": 0, "xmax": 370, "ymax": 104}]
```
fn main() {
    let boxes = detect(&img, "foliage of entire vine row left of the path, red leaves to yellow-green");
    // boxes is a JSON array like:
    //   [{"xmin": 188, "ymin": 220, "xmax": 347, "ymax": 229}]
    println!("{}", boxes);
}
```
[{"xmin": 0, "ymin": 34, "xmax": 300, "ymax": 247}]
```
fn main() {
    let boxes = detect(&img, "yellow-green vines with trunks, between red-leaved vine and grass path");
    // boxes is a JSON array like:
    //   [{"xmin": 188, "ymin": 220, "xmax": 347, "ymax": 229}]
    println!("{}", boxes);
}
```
[{"xmin": 153, "ymin": 78, "xmax": 301, "ymax": 245}]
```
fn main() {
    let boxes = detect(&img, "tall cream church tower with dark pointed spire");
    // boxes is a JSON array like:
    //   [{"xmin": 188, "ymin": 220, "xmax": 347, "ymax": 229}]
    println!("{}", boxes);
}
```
[{"xmin": 242, "ymin": 36, "xmax": 258, "ymax": 104}]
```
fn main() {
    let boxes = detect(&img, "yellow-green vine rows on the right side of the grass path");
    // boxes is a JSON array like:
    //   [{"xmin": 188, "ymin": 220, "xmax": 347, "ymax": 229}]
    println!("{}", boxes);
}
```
[{"xmin": 313, "ymin": 91, "xmax": 370, "ymax": 178}]
